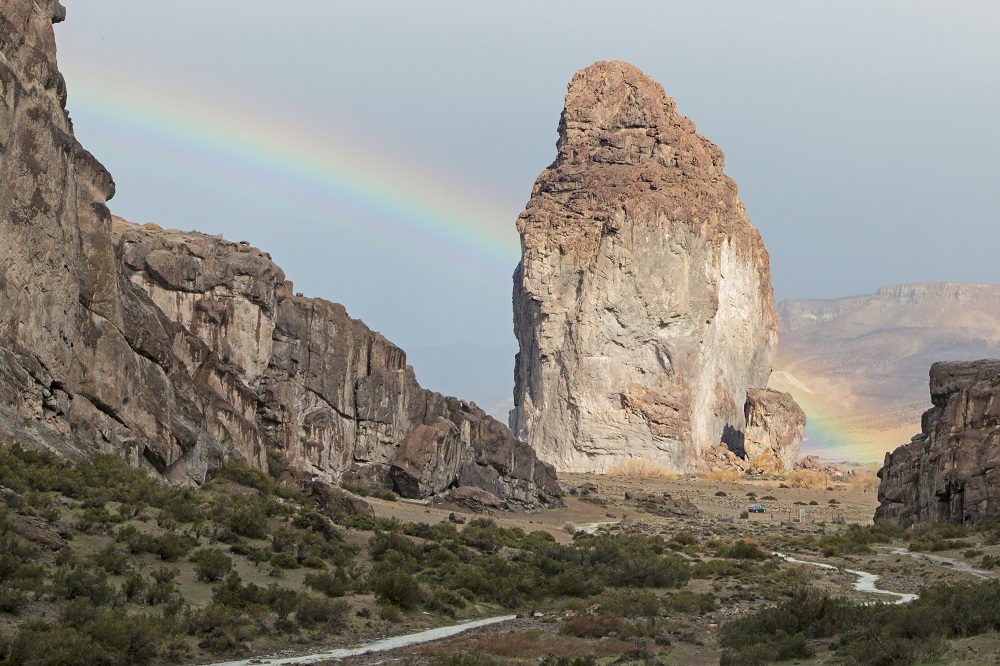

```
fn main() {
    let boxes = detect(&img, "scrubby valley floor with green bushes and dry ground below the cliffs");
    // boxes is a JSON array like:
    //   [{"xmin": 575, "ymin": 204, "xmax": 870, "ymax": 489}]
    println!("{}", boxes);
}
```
[{"xmin": 0, "ymin": 449, "xmax": 1000, "ymax": 666}]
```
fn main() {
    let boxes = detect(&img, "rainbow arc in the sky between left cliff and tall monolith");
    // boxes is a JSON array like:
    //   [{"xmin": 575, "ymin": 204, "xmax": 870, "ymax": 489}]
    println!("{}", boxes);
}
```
[{"xmin": 67, "ymin": 65, "xmax": 520, "ymax": 285}]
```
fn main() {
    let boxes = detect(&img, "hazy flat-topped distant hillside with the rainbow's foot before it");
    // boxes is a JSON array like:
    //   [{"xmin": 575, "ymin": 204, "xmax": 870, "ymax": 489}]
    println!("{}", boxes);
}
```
[{"xmin": 770, "ymin": 283, "xmax": 1000, "ymax": 462}]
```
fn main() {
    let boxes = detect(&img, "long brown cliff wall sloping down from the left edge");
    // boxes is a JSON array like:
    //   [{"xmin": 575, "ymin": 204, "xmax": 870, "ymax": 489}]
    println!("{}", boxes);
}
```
[{"xmin": 0, "ymin": 0, "xmax": 559, "ymax": 506}]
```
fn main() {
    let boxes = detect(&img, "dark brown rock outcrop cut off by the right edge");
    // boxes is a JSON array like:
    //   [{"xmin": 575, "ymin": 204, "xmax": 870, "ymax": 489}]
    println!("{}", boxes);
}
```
[{"xmin": 875, "ymin": 360, "xmax": 1000, "ymax": 527}]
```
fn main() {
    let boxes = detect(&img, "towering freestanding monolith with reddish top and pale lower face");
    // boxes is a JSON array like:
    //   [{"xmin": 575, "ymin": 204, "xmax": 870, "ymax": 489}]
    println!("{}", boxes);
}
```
[{"xmin": 511, "ymin": 61, "xmax": 776, "ymax": 472}]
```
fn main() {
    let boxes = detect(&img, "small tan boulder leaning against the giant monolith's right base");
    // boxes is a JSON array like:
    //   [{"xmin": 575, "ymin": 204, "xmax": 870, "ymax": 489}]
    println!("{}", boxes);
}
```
[{"xmin": 742, "ymin": 389, "xmax": 806, "ymax": 474}]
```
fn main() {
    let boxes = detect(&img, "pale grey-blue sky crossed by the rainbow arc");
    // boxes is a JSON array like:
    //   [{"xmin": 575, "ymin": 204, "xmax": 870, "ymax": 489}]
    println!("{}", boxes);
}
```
[{"xmin": 56, "ymin": 0, "xmax": 1000, "ymax": 406}]
